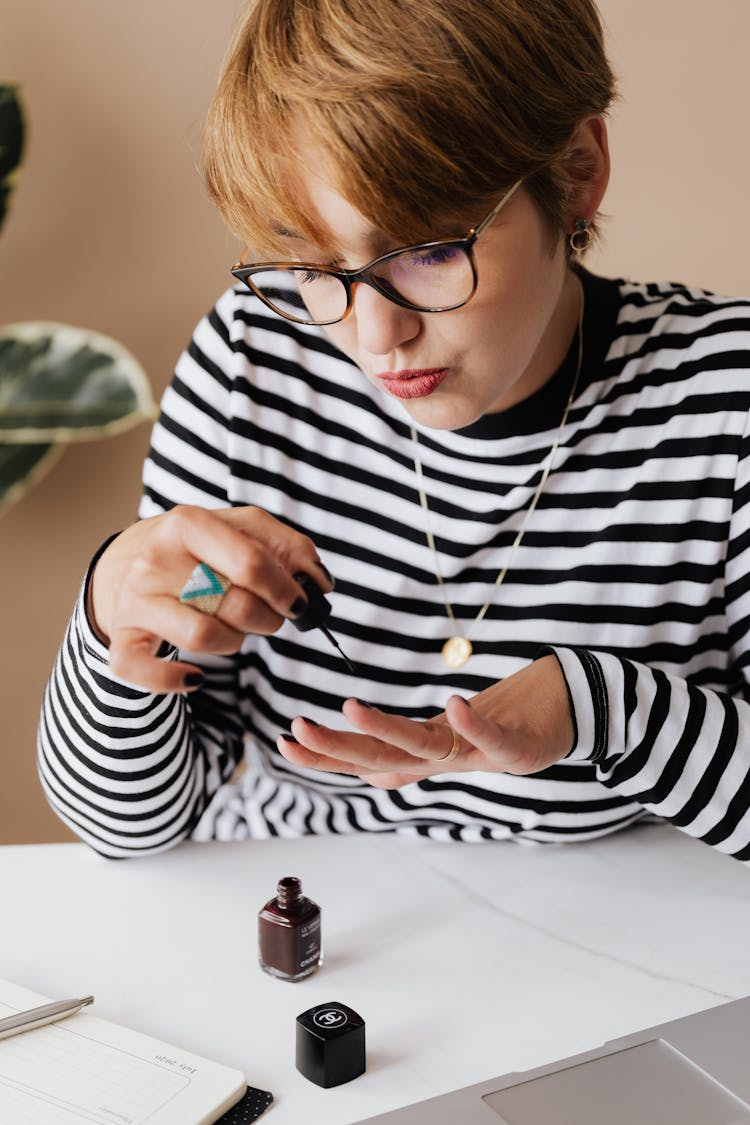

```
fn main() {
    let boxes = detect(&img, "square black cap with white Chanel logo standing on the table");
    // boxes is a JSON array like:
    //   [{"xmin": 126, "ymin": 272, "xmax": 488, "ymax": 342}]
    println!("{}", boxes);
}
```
[{"xmin": 296, "ymin": 1001, "xmax": 365, "ymax": 1088}]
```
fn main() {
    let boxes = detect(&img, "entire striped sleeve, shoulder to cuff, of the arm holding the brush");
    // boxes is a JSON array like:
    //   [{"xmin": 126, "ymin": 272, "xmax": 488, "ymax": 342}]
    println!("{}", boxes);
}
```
[{"xmin": 37, "ymin": 294, "xmax": 243, "ymax": 857}]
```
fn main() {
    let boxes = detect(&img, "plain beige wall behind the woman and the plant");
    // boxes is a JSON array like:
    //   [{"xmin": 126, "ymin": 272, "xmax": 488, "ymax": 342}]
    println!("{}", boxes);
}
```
[{"xmin": 0, "ymin": 0, "xmax": 750, "ymax": 843}]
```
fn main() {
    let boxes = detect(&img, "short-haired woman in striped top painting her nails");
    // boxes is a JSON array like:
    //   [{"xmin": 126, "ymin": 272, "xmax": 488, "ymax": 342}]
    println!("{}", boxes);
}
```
[{"xmin": 39, "ymin": 0, "xmax": 750, "ymax": 861}]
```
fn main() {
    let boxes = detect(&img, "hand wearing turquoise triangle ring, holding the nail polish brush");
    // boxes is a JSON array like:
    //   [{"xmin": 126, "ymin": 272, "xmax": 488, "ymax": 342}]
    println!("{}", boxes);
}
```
[{"xmin": 88, "ymin": 505, "xmax": 333, "ymax": 693}]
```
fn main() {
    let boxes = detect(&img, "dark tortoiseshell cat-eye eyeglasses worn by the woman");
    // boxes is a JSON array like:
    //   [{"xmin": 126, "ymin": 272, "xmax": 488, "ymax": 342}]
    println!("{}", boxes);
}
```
[{"xmin": 232, "ymin": 180, "xmax": 523, "ymax": 325}]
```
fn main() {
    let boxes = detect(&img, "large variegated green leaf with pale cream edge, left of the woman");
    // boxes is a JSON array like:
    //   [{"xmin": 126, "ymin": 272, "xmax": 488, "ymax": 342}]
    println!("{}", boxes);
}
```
[{"xmin": 0, "ymin": 322, "xmax": 156, "ymax": 444}]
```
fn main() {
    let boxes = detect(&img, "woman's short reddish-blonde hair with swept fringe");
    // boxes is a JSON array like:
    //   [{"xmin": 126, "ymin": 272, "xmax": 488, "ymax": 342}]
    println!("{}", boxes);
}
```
[{"xmin": 204, "ymin": 0, "xmax": 614, "ymax": 253}]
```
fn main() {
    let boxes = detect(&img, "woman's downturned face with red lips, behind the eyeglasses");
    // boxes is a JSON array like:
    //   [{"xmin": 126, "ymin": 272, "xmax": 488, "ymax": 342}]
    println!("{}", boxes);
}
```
[{"xmin": 281, "ymin": 150, "xmax": 581, "ymax": 430}]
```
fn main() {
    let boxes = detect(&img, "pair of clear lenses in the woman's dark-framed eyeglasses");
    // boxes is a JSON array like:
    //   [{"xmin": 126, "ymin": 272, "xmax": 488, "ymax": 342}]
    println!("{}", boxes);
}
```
[{"xmin": 252, "ymin": 244, "xmax": 473, "ymax": 324}]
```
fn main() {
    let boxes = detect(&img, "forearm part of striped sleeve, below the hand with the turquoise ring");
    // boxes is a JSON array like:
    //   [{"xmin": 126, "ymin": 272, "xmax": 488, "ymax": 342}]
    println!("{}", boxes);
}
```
[{"xmin": 38, "ymin": 555, "xmax": 243, "ymax": 858}]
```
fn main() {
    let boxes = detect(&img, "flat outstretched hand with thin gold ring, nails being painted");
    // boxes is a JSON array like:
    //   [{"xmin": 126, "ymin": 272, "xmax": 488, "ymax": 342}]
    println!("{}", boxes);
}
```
[{"xmin": 277, "ymin": 655, "xmax": 575, "ymax": 789}]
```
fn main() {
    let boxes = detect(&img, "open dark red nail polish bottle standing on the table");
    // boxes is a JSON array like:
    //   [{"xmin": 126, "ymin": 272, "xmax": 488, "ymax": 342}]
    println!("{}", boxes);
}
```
[{"xmin": 257, "ymin": 875, "xmax": 320, "ymax": 981}]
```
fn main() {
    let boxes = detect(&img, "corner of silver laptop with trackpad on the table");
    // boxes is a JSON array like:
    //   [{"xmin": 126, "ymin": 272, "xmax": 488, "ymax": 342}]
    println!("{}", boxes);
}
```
[{"xmin": 359, "ymin": 997, "xmax": 750, "ymax": 1125}]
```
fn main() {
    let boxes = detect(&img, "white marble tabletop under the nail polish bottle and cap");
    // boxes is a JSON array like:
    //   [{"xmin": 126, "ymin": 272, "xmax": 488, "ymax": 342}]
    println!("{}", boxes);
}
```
[{"xmin": 0, "ymin": 826, "xmax": 750, "ymax": 1125}]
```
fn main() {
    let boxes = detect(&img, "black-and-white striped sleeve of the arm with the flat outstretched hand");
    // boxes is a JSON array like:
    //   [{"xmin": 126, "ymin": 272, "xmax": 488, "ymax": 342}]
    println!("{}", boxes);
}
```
[{"xmin": 553, "ymin": 409, "xmax": 750, "ymax": 861}]
